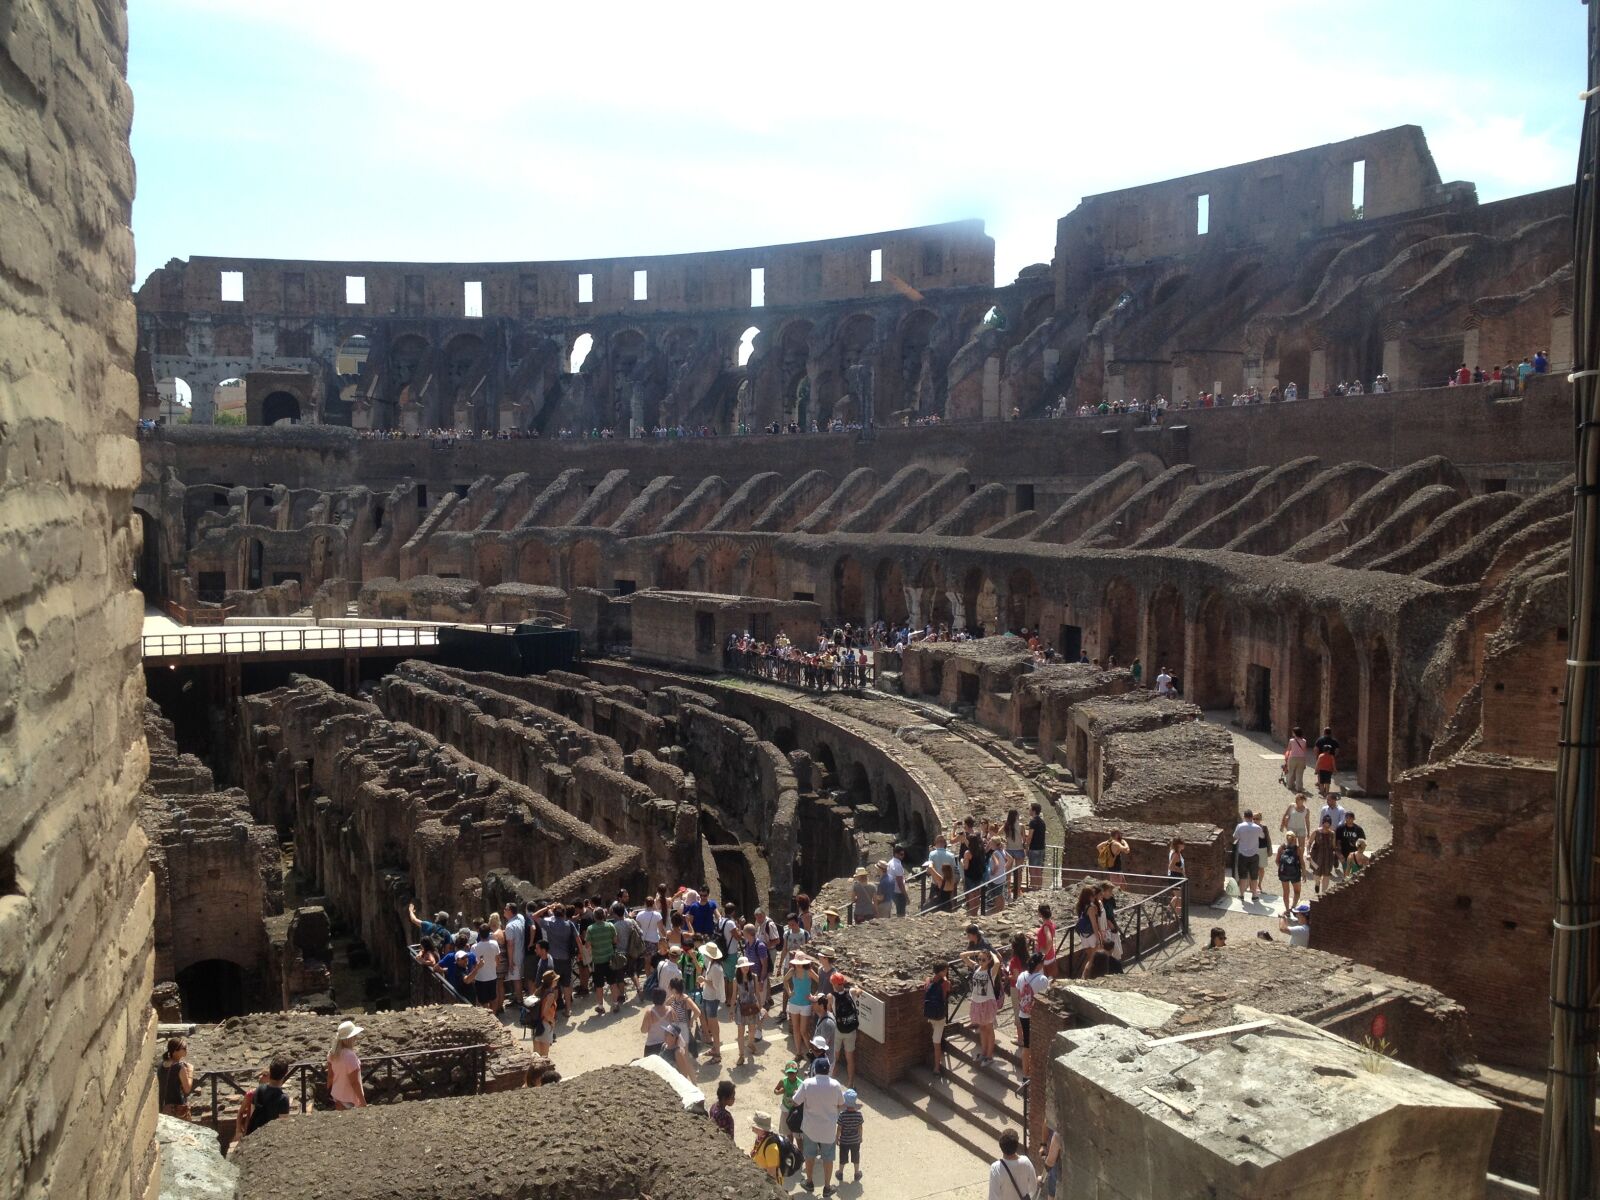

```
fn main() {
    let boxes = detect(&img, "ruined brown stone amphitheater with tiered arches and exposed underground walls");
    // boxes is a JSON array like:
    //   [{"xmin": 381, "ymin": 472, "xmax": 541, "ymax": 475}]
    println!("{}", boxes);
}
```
[{"xmin": 0, "ymin": 0, "xmax": 1593, "ymax": 1200}]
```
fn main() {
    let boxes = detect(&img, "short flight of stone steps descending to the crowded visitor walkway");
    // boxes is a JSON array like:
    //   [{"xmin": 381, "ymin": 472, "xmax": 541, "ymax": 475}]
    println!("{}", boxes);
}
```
[{"xmin": 890, "ymin": 1024, "xmax": 1024, "ymax": 1162}]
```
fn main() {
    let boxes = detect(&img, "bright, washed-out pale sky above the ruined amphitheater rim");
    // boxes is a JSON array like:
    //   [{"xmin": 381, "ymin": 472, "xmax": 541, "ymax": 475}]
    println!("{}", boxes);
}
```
[{"xmin": 128, "ymin": 0, "xmax": 1584, "ymax": 289}]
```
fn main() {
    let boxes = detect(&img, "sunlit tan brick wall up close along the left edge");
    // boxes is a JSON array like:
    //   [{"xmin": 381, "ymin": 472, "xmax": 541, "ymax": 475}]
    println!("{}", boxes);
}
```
[{"xmin": 0, "ymin": 0, "xmax": 155, "ymax": 1198}]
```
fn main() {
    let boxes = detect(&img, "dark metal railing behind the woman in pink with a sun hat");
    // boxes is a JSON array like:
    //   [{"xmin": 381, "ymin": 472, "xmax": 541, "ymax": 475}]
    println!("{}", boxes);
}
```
[{"xmin": 172, "ymin": 1043, "xmax": 490, "ymax": 1136}]
